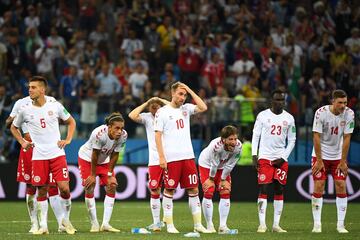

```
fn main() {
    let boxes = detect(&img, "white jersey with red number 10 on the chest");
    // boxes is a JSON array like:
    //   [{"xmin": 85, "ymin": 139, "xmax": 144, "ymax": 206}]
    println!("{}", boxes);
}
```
[{"xmin": 155, "ymin": 103, "xmax": 196, "ymax": 162}]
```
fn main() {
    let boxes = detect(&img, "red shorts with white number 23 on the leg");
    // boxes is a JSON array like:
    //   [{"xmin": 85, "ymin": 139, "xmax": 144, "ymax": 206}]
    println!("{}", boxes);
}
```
[{"xmin": 258, "ymin": 159, "xmax": 289, "ymax": 185}]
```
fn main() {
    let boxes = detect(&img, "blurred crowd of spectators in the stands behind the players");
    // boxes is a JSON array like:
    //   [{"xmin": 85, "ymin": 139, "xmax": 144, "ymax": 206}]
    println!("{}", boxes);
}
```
[{"xmin": 0, "ymin": 0, "xmax": 360, "ymax": 161}]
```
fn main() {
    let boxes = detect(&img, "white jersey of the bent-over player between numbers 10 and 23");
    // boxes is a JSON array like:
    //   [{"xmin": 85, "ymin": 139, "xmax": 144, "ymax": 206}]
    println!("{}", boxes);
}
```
[{"xmin": 199, "ymin": 137, "xmax": 242, "ymax": 179}]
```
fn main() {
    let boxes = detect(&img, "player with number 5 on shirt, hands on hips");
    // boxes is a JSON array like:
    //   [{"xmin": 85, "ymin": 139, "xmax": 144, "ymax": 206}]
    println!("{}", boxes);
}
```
[{"xmin": 10, "ymin": 76, "xmax": 76, "ymax": 234}]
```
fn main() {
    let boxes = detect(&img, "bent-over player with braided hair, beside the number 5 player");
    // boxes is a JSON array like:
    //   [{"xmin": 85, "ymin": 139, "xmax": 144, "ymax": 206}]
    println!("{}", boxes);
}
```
[{"xmin": 78, "ymin": 112, "xmax": 127, "ymax": 232}]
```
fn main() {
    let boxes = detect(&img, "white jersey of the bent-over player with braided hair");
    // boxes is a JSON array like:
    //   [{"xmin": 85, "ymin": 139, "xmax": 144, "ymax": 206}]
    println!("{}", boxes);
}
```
[{"xmin": 79, "ymin": 125, "xmax": 127, "ymax": 164}]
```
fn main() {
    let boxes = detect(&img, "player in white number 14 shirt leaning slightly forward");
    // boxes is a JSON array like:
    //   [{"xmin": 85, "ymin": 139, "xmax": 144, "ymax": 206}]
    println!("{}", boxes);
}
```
[{"xmin": 311, "ymin": 89, "xmax": 355, "ymax": 233}]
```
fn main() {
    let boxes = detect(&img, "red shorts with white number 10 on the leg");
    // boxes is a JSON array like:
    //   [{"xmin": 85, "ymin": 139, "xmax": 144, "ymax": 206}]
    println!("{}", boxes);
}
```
[{"xmin": 164, "ymin": 159, "xmax": 198, "ymax": 189}]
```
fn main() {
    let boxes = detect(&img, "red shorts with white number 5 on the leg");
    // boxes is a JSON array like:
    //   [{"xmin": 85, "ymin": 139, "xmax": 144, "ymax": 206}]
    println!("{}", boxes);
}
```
[{"xmin": 31, "ymin": 155, "xmax": 69, "ymax": 186}]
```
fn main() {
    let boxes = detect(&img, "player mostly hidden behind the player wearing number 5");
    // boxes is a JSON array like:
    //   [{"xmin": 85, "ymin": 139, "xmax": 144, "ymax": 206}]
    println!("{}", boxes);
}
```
[{"xmin": 6, "ymin": 96, "xmax": 64, "ymax": 233}]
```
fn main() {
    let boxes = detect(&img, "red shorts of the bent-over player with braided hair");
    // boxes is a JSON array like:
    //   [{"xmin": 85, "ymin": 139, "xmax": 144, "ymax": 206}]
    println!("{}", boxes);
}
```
[{"xmin": 78, "ymin": 157, "xmax": 115, "ymax": 186}]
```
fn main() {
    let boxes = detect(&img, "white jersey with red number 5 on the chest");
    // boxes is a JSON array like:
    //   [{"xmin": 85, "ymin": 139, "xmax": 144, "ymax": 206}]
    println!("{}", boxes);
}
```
[{"xmin": 13, "ymin": 99, "xmax": 70, "ymax": 160}]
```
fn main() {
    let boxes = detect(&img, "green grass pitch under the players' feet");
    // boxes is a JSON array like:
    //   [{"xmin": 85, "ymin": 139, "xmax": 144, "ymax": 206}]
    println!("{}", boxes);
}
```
[{"xmin": 0, "ymin": 200, "xmax": 360, "ymax": 240}]
